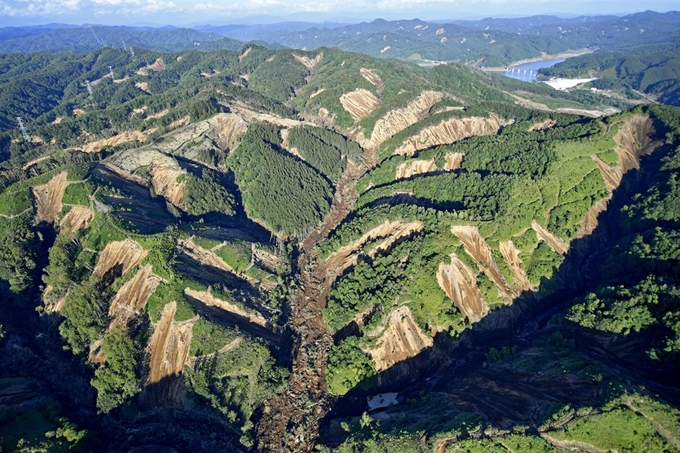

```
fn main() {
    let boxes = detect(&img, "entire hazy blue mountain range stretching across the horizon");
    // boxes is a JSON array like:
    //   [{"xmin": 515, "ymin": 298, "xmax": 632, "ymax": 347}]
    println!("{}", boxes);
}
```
[{"xmin": 0, "ymin": 11, "xmax": 680, "ymax": 67}]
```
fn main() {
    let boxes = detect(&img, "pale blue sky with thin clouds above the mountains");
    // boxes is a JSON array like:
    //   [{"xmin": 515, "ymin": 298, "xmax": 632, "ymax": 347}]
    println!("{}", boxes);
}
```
[{"xmin": 0, "ymin": 0, "xmax": 680, "ymax": 27}]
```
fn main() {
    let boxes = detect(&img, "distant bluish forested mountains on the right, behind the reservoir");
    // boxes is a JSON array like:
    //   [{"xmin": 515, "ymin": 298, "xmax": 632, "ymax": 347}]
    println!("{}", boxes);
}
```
[{"xmin": 211, "ymin": 11, "xmax": 680, "ymax": 67}]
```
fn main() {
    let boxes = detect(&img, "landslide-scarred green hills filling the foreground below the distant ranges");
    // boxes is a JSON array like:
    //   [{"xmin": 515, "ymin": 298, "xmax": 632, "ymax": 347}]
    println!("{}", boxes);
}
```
[{"xmin": 0, "ymin": 44, "xmax": 680, "ymax": 452}]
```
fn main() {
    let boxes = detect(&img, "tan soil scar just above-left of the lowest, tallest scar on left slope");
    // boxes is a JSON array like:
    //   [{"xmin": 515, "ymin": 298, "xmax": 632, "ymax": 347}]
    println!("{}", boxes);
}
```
[{"xmin": 109, "ymin": 264, "xmax": 161, "ymax": 329}]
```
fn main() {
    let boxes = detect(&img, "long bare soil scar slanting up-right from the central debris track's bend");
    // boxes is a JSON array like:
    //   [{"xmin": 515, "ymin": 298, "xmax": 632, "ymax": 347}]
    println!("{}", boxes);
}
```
[{"xmin": 325, "ymin": 220, "xmax": 424, "ymax": 275}]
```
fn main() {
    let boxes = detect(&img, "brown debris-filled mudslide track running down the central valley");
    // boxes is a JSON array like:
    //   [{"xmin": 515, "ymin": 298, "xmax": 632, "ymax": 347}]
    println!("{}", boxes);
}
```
[{"xmin": 255, "ymin": 151, "xmax": 373, "ymax": 452}]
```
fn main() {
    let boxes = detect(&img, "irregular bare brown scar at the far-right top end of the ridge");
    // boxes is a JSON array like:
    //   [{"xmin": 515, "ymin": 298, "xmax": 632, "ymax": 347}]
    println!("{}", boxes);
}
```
[{"xmin": 592, "ymin": 115, "xmax": 661, "ymax": 191}]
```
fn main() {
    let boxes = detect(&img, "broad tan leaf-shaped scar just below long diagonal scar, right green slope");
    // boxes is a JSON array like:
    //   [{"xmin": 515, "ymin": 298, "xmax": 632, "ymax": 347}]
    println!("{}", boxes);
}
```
[{"xmin": 437, "ymin": 253, "xmax": 489, "ymax": 323}]
